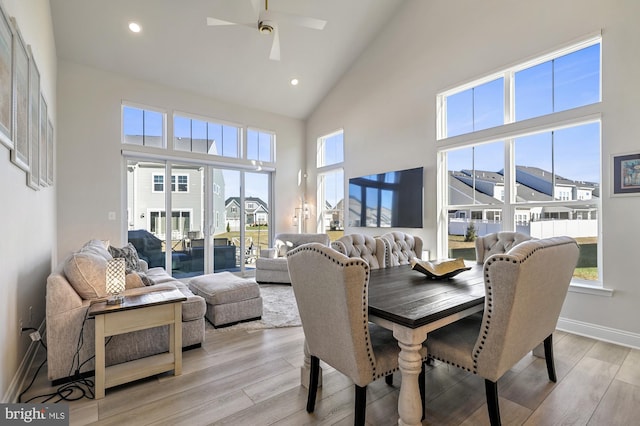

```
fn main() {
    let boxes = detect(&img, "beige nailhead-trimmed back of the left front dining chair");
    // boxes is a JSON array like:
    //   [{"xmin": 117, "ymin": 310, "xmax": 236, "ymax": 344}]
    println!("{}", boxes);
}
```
[{"xmin": 287, "ymin": 243, "xmax": 376, "ymax": 386}]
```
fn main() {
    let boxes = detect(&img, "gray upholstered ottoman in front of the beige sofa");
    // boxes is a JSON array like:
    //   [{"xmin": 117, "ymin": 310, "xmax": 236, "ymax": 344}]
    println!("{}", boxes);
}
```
[{"xmin": 189, "ymin": 272, "xmax": 262, "ymax": 327}]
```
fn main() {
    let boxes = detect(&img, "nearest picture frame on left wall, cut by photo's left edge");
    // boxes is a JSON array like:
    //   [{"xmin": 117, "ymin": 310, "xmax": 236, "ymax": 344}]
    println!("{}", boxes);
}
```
[{"xmin": 0, "ymin": 5, "xmax": 14, "ymax": 149}]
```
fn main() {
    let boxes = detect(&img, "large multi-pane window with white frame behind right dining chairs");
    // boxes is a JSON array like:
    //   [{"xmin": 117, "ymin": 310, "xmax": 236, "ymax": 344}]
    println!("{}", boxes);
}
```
[{"xmin": 438, "ymin": 37, "xmax": 601, "ymax": 283}]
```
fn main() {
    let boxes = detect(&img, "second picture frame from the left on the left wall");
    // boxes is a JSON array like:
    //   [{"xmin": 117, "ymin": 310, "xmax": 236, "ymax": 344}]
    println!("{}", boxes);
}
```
[{"xmin": 11, "ymin": 18, "xmax": 29, "ymax": 172}]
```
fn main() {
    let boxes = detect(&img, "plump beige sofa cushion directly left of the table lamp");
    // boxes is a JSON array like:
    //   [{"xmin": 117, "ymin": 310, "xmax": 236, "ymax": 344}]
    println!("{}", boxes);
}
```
[{"xmin": 64, "ymin": 251, "xmax": 107, "ymax": 300}]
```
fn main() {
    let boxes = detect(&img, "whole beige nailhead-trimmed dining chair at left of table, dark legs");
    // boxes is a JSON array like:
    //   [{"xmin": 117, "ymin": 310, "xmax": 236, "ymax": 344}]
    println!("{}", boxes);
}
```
[{"xmin": 287, "ymin": 243, "xmax": 426, "ymax": 425}]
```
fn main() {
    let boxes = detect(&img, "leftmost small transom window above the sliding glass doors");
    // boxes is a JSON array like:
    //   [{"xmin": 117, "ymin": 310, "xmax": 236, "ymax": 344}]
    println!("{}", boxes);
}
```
[{"xmin": 122, "ymin": 105, "xmax": 166, "ymax": 148}]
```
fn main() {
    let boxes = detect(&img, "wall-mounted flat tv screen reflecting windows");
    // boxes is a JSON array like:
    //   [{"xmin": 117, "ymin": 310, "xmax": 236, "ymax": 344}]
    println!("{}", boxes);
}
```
[{"xmin": 349, "ymin": 167, "xmax": 423, "ymax": 228}]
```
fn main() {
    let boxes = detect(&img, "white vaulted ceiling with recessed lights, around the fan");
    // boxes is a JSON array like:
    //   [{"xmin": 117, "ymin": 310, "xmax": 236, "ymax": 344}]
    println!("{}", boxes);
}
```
[{"xmin": 50, "ymin": 0, "xmax": 404, "ymax": 119}]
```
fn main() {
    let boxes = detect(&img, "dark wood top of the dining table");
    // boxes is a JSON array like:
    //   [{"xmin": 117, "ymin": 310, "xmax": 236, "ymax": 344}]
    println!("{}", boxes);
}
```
[{"xmin": 369, "ymin": 263, "xmax": 485, "ymax": 328}]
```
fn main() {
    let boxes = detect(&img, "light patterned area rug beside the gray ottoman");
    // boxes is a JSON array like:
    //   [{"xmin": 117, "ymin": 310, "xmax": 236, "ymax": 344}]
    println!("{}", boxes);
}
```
[{"xmin": 207, "ymin": 284, "xmax": 302, "ymax": 333}]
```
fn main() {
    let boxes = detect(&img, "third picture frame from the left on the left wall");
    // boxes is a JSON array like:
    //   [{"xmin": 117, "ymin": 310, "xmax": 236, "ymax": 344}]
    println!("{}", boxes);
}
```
[{"xmin": 27, "ymin": 46, "xmax": 40, "ymax": 190}]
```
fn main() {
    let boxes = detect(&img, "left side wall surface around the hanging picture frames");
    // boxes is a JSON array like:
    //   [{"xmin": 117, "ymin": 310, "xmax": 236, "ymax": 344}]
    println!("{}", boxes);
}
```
[{"xmin": 0, "ymin": 0, "xmax": 56, "ymax": 402}]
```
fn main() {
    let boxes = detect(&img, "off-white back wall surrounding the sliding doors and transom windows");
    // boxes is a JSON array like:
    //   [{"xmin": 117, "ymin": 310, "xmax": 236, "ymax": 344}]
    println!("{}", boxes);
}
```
[{"xmin": 57, "ymin": 60, "xmax": 304, "ymax": 259}]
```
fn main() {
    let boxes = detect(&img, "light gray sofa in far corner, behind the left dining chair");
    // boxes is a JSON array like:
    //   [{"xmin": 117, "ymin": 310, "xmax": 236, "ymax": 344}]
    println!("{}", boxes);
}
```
[{"xmin": 256, "ymin": 234, "xmax": 329, "ymax": 284}]
